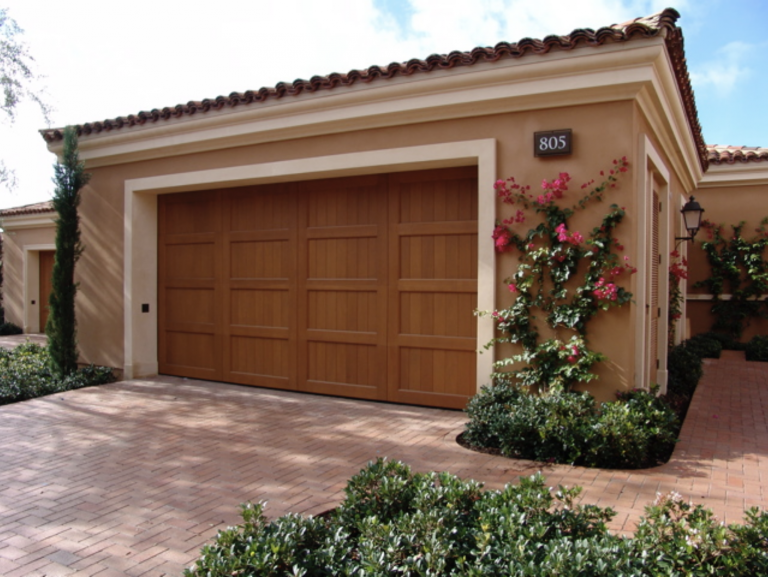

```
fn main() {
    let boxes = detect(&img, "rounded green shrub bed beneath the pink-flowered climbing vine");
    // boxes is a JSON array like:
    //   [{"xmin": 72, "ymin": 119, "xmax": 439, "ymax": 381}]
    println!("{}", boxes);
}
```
[{"xmin": 463, "ymin": 383, "xmax": 679, "ymax": 468}]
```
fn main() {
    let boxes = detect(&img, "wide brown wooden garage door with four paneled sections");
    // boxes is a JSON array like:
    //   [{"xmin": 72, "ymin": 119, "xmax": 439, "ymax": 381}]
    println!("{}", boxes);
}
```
[{"xmin": 158, "ymin": 168, "xmax": 477, "ymax": 407}]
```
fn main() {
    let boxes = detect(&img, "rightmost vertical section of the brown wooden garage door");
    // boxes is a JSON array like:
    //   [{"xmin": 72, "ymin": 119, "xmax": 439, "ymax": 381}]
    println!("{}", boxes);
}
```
[{"xmin": 388, "ymin": 168, "xmax": 477, "ymax": 408}]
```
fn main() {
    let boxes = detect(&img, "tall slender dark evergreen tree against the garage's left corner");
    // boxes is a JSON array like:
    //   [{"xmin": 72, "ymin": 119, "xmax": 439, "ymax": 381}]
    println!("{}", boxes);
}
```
[{"xmin": 45, "ymin": 127, "xmax": 91, "ymax": 376}]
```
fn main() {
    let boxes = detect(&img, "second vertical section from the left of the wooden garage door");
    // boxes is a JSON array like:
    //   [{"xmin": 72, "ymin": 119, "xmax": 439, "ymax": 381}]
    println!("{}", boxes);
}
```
[{"xmin": 221, "ymin": 184, "xmax": 297, "ymax": 389}]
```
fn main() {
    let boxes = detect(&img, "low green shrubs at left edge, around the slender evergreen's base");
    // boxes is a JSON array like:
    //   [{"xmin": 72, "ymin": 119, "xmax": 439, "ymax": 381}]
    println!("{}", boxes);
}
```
[{"xmin": 0, "ymin": 343, "xmax": 115, "ymax": 405}]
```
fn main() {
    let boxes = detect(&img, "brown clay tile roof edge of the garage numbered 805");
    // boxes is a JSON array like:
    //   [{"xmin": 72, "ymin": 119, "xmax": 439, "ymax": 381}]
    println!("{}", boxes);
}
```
[{"xmin": 40, "ymin": 8, "xmax": 707, "ymax": 169}]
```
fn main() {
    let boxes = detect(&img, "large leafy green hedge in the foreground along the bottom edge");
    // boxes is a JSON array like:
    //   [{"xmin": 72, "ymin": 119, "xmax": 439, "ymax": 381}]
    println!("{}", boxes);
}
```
[{"xmin": 185, "ymin": 459, "xmax": 768, "ymax": 576}]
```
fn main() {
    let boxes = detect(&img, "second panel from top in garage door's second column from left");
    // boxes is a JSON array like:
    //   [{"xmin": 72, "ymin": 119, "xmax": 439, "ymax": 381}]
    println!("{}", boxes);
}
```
[{"xmin": 230, "ymin": 241, "xmax": 291, "ymax": 279}]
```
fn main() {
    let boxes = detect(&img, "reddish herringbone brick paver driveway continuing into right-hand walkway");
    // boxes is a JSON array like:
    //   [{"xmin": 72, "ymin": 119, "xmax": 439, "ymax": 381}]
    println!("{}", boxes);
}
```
[{"xmin": 0, "ymin": 348, "xmax": 768, "ymax": 575}]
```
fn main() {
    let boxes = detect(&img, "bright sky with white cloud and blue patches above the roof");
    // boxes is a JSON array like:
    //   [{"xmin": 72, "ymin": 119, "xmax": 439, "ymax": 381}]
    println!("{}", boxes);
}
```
[{"xmin": 0, "ymin": 0, "xmax": 768, "ymax": 208}]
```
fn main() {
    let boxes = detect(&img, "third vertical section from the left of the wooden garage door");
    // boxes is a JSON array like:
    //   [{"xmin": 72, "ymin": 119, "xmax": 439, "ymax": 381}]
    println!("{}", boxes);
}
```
[{"xmin": 298, "ymin": 175, "xmax": 387, "ymax": 400}]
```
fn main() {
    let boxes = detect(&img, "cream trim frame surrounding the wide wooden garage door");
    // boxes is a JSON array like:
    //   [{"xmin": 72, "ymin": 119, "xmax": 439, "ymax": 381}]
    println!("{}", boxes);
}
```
[{"xmin": 123, "ymin": 139, "xmax": 497, "ymax": 389}]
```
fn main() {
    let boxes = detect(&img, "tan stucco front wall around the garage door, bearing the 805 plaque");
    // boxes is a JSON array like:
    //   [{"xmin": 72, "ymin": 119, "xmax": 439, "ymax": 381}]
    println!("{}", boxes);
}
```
[{"xmin": 77, "ymin": 95, "xmax": 672, "ymax": 398}]
